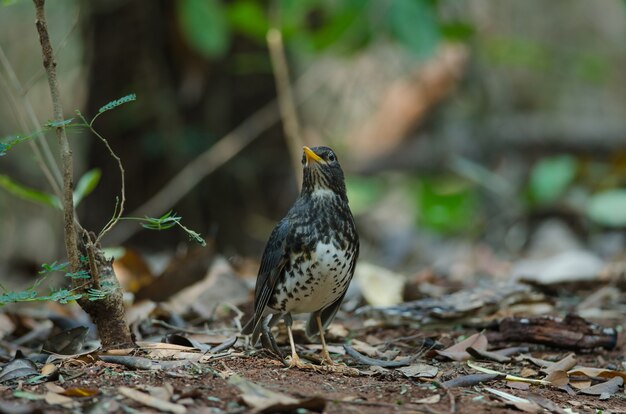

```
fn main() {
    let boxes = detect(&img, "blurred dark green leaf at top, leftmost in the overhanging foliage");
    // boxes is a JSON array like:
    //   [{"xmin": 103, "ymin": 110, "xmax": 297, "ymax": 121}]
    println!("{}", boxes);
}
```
[{"xmin": 176, "ymin": 0, "xmax": 230, "ymax": 58}]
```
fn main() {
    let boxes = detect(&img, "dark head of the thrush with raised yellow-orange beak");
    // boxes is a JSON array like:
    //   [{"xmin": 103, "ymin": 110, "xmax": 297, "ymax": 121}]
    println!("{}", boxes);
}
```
[{"xmin": 302, "ymin": 147, "xmax": 346, "ymax": 198}]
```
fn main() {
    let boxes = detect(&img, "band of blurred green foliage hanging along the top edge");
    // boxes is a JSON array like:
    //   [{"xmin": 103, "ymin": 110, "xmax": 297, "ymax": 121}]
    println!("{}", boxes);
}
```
[{"xmin": 176, "ymin": 0, "xmax": 473, "ymax": 58}]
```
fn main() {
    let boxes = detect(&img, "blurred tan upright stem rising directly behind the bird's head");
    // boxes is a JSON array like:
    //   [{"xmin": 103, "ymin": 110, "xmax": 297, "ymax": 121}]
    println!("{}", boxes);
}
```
[{"xmin": 267, "ymin": 2, "xmax": 302, "ymax": 185}]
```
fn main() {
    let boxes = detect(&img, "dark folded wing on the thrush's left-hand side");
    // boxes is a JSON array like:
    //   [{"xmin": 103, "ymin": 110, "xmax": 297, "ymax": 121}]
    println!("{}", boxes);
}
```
[{"xmin": 242, "ymin": 218, "xmax": 289, "ymax": 334}]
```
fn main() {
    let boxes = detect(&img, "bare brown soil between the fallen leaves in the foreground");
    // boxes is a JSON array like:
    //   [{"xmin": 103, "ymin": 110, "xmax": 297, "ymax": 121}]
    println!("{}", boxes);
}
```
[{"xmin": 0, "ymin": 322, "xmax": 626, "ymax": 413}]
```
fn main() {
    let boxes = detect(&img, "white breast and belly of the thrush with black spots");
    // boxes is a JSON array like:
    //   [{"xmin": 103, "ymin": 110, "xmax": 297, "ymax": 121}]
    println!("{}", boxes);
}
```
[{"xmin": 275, "ymin": 242, "xmax": 354, "ymax": 313}]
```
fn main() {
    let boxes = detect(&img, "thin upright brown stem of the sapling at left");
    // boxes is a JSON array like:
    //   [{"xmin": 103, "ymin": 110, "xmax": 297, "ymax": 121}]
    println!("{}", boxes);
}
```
[{"xmin": 33, "ymin": 0, "xmax": 80, "ymax": 272}]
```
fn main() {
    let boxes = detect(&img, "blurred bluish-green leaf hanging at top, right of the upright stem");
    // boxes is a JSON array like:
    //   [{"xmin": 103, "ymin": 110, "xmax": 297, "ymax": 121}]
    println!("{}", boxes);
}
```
[{"xmin": 387, "ymin": 0, "xmax": 441, "ymax": 57}]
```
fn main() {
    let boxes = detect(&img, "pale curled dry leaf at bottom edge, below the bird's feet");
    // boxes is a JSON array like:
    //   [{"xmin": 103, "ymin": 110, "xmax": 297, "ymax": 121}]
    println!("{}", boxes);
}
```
[{"xmin": 228, "ymin": 375, "xmax": 326, "ymax": 413}]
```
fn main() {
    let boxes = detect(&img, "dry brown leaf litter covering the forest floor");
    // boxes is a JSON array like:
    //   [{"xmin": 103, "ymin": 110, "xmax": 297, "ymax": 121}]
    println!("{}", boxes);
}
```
[{"xmin": 0, "ymin": 247, "xmax": 626, "ymax": 413}]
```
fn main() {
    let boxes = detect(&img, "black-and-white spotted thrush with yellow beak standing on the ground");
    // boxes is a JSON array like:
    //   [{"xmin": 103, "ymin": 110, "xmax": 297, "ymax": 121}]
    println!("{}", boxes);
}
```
[{"xmin": 242, "ymin": 147, "xmax": 359, "ymax": 368}]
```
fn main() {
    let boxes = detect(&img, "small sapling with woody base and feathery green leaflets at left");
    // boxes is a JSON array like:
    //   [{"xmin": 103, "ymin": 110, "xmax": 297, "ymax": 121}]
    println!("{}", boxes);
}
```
[{"xmin": 0, "ymin": 0, "xmax": 204, "ymax": 349}]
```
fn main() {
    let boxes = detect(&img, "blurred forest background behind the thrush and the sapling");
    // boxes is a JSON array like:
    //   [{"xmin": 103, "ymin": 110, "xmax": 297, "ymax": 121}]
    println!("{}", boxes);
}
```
[{"xmin": 0, "ymin": 0, "xmax": 626, "ymax": 300}]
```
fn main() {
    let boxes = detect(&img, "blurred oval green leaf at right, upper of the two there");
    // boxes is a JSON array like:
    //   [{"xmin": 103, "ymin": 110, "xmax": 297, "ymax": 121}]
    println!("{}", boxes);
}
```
[{"xmin": 529, "ymin": 155, "xmax": 577, "ymax": 204}]
